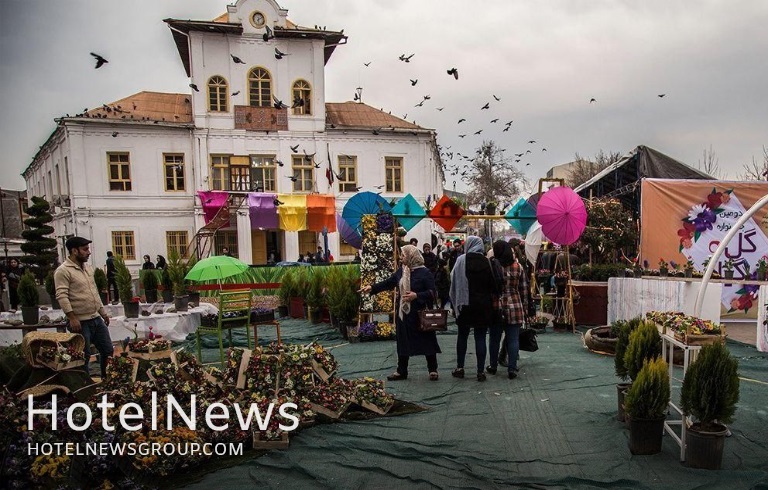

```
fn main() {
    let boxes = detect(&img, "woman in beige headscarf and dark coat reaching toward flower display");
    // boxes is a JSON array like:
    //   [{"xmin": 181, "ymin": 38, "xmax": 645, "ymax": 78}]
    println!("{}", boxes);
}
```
[{"xmin": 360, "ymin": 245, "xmax": 441, "ymax": 381}]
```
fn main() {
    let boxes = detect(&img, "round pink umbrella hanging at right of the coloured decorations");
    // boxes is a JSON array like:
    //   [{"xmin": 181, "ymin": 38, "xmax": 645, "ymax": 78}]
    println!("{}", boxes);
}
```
[{"xmin": 536, "ymin": 187, "xmax": 587, "ymax": 245}]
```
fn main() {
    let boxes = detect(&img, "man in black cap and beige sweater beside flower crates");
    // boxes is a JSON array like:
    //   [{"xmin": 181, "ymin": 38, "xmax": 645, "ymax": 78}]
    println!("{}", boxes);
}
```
[{"xmin": 53, "ymin": 236, "xmax": 114, "ymax": 379}]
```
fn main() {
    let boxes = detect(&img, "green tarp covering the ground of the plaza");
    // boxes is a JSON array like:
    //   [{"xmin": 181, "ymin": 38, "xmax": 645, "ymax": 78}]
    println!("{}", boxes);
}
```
[{"xmin": 182, "ymin": 320, "xmax": 768, "ymax": 490}]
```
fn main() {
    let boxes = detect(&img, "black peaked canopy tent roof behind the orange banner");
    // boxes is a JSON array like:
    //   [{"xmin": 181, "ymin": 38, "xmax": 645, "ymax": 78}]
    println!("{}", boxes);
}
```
[{"xmin": 574, "ymin": 145, "xmax": 714, "ymax": 218}]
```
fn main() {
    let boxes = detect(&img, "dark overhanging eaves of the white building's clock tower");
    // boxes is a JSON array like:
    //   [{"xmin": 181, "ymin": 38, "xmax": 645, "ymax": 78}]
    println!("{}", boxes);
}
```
[{"xmin": 168, "ymin": 13, "xmax": 347, "ymax": 77}]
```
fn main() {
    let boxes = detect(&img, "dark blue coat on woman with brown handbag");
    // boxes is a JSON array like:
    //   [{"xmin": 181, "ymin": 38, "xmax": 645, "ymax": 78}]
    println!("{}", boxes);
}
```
[{"xmin": 371, "ymin": 267, "xmax": 442, "ymax": 356}]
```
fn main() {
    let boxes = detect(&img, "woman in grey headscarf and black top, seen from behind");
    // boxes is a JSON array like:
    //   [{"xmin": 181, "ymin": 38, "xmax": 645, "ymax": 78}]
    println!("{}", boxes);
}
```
[{"xmin": 450, "ymin": 236, "xmax": 498, "ymax": 381}]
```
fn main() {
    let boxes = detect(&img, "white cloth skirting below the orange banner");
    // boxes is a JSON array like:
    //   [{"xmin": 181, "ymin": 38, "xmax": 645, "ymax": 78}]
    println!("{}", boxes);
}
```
[{"xmin": 608, "ymin": 277, "xmax": 723, "ymax": 324}]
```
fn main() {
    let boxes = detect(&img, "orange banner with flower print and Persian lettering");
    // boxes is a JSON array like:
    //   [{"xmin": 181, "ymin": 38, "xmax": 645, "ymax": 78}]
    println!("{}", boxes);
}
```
[{"xmin": 640, "ymin": 179, "xmax": 768, "ymax": 319}]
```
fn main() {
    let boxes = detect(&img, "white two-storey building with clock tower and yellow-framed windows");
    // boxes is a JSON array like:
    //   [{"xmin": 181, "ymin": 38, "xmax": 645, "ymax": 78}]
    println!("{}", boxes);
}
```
[{"xmin": 23, "ymin": 0, "xmax": 444, "ymax": 269}]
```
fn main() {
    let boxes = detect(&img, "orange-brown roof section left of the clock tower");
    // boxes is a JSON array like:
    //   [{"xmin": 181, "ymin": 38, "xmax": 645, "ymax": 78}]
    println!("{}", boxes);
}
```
[{"xmin": 78, "ymin": 91, "xmax": 192, "ymax": 124}]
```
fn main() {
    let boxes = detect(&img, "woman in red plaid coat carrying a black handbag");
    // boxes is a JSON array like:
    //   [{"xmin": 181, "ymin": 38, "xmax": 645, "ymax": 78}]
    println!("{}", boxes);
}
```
[{"xmin": 486, "ymin": 240, "xmax": 528, "ymax": 379}]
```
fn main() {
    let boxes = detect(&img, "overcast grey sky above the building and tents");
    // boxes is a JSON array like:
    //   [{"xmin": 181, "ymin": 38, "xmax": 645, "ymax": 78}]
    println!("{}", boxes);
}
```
[{"xmin": 0, "ymin": 0, "xmax": 768, "ymax": 193}]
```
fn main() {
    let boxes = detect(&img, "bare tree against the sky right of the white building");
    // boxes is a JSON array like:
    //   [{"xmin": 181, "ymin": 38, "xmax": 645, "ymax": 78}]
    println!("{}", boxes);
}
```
[{"xmin": 462, "ymin": 141, "xmax": 529, "ymax": 206}]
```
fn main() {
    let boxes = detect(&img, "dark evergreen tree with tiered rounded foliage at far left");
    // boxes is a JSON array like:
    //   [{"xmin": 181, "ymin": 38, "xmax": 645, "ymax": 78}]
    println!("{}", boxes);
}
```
[{"xmin": 21, "ymin": 196, "xmax": 58, "ymax": 279}]
